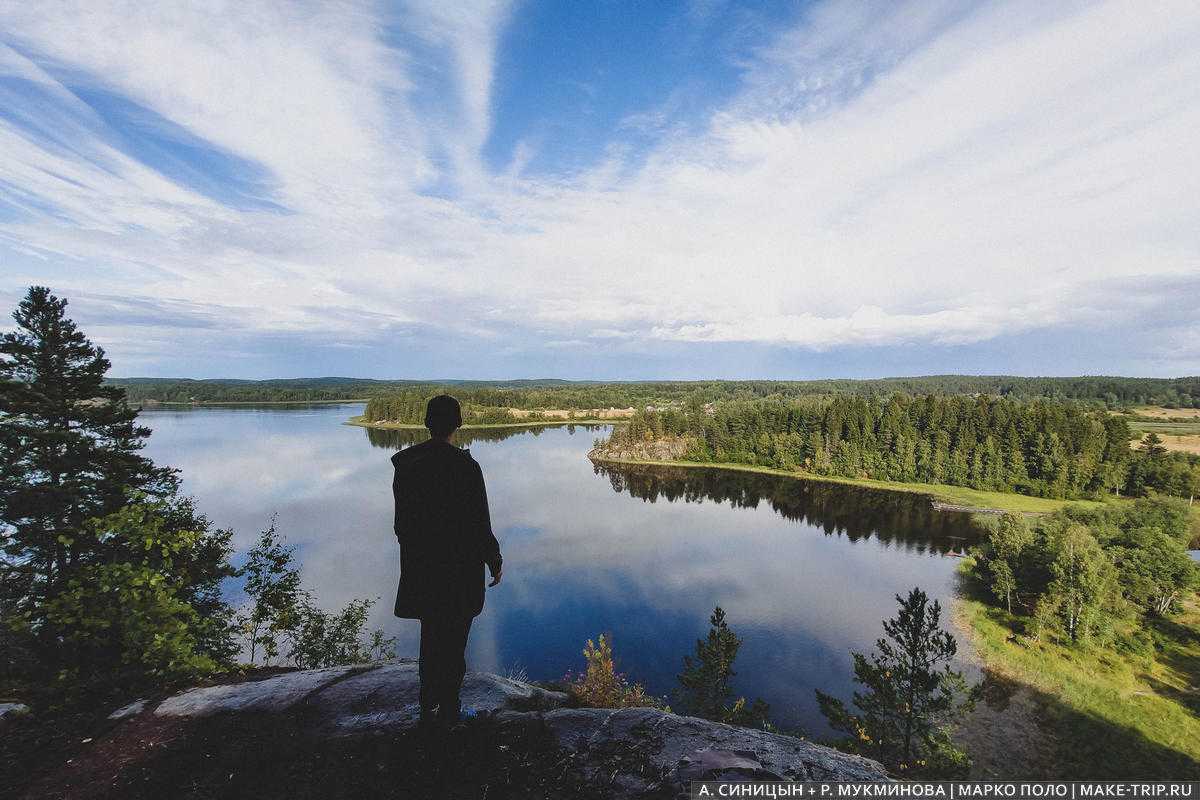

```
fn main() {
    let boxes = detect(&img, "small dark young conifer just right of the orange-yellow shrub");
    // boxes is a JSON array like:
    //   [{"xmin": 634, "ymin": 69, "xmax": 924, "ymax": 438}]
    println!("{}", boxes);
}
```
[{"xmin": 678, "ymin": 606, "xmax": 770, "ymax": 727}]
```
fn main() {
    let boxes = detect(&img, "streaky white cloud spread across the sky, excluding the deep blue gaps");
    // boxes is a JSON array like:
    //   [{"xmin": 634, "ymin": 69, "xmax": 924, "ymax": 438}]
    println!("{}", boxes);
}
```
[{"xmin": 0, "ymin": 2, "xmax": 1200, "ymax": 369}]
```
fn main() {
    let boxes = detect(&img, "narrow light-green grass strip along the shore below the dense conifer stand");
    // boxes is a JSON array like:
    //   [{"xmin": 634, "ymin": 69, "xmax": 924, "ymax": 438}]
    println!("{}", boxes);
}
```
[{"xmin": 590, "ymin": 459, "xmax": 1104, "ymax": 513}]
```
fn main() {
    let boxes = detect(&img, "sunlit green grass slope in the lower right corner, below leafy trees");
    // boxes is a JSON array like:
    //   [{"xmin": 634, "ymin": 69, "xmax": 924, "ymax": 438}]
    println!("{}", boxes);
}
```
[{"xmin": 956, "ymin": 560, "xmax": 1200, "ymax": 780}]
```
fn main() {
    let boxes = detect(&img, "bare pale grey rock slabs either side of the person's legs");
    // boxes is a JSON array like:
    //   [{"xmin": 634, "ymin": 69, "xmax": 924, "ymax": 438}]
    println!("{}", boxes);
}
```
[{"xmin": 88, "ymin": 660, "xmax": 888, "ymax": 798}]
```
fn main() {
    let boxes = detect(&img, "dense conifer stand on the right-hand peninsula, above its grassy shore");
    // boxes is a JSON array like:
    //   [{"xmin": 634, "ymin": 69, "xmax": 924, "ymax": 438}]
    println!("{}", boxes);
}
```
[{"xmin": 604, "ymin": 393, "xmax": 1200, "ymax": 498}]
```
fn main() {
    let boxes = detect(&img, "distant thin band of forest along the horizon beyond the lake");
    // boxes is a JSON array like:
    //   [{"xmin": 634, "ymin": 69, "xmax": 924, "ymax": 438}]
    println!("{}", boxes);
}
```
[{"xmin": 114, "ymin": 375, "xmax": 1200, "ymax": 410}]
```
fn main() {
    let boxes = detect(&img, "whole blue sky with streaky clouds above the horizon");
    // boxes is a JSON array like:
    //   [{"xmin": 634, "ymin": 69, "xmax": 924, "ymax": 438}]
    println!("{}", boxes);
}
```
[{"xmin": 0, "ymin": 0, "xmax": 1200, "ymax": 379}]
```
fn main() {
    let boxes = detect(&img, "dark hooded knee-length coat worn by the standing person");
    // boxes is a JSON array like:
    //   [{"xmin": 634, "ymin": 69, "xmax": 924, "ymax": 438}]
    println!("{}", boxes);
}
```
[{"xmin": 391, "ymin": 439, "xmax": 500, "ymax": 619}]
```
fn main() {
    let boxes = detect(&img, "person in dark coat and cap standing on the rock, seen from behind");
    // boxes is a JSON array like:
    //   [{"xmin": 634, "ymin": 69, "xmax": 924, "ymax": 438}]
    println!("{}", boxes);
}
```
[{"xmin": 391, "ymin": 395, "xmax": 502, "ymax": 723}]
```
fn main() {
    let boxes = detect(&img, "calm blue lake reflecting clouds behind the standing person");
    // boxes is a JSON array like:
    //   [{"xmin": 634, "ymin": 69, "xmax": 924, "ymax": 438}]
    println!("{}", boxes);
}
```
[{"xmin": 142, "ymin": 404, "xmax": 972, "ymax": 734}]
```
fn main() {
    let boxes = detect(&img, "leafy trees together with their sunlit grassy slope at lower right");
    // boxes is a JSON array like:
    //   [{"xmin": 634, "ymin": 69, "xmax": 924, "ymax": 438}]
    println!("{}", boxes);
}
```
[{"xmin": 961, "ymin": 498, "xmax": 1200, "ymax": 780}]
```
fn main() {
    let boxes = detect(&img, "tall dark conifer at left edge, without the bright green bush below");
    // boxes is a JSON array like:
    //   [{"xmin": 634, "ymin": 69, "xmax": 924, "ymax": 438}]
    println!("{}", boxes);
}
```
[{"xmin": 0, "ymin": 287, "xmax": 176, "ymax": 599}]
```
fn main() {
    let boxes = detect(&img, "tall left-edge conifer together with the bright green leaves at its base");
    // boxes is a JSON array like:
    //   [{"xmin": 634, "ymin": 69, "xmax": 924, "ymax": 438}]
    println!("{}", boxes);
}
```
[{"xmin": 0, "ymin": 287, "xmax": 236, "ymax": 700}]
